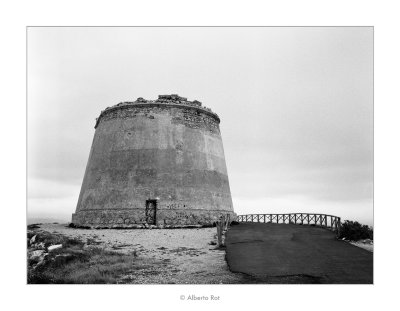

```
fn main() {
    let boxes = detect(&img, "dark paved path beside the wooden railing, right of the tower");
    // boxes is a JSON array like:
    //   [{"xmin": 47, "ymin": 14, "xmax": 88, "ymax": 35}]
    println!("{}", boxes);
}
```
[{"xmin": 226, "ymin": 223, "xmax": 373, "ymax": 284}]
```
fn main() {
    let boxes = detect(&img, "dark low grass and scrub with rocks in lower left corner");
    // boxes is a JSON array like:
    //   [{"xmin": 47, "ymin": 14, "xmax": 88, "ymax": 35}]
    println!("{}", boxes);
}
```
[{"xmin": 28, "ymin": 230, "xmax": 141, "ymax": 284}]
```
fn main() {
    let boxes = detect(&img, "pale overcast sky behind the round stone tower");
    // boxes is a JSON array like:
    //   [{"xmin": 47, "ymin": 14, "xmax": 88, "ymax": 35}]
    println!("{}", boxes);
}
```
[{"xmin": 27, "ymin": 27, "xmax": 373, "ymax": 225}]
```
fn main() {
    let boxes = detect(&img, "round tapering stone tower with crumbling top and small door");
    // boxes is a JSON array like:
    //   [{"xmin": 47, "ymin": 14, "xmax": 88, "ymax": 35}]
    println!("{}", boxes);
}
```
[{"xmin": 72, "ymin": 94, "xmax": 234, "ymax": 228}]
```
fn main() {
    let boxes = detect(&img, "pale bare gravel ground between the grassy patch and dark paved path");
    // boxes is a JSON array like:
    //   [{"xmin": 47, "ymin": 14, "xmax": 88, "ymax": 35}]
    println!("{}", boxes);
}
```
[{"xmin": 40, "ymin": 224, "xmax": 248, "ymax": 284}]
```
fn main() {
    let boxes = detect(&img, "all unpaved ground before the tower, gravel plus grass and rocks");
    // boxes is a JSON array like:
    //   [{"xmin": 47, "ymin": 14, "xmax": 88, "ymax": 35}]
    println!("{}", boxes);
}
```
[{"xmin": 27, "ymin": 224, "xmax": 373, "ymax": 284}]
